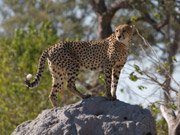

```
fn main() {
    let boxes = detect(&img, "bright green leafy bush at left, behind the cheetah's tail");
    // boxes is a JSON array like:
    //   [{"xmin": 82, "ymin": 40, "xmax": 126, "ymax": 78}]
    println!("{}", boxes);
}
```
[{"xmin": 0, "ymin": 22, "xmax": 58, "ymax": 135}]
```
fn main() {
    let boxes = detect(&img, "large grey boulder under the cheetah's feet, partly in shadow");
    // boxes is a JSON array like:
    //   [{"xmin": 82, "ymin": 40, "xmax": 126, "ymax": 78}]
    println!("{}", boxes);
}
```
[{"xmin": 12, "ymin": 97, "xmax": 156, "ymax": 135}]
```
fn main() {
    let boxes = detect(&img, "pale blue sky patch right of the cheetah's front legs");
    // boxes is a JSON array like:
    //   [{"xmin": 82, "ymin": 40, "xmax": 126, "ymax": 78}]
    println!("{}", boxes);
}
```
[{"xmin": 117, "ymin": 46, "xmax": 180, "ymax": 107}]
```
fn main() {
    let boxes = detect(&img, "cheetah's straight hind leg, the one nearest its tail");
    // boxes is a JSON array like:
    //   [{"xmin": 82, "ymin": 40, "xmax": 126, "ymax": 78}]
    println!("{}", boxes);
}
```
[{"xmin": 49, "ymin": 68, "xmax": 65, "ymax": 107}]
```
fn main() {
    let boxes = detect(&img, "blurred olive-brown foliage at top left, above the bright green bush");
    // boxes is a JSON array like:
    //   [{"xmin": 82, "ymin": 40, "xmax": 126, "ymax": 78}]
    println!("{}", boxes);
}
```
[{"xmin": 0, "ymin": 0, "xmax": 89, "ymax": 39}]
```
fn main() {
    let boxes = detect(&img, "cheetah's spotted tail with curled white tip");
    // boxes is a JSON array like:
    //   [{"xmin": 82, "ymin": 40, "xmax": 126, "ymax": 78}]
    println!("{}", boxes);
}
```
[{"xmin": 25, "ymin": 50, "xmax": 48, "ymax": 88}]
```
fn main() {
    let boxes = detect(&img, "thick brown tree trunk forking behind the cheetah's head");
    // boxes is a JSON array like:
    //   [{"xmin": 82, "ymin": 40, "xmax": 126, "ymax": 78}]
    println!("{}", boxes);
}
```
[{"xmin": 89, "ymin": 0, "xmax": 130, "ymax": 39}]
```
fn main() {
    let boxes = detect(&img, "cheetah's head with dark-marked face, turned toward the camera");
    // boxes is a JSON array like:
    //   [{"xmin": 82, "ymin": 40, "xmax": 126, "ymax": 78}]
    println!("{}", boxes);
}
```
[{"xmin": 115, "ymin": 24, "xmax": 134, "ymax": 46}]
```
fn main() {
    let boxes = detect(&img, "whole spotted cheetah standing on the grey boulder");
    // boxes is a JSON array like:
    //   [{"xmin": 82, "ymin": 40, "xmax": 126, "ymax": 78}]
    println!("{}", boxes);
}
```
[{"xmin": 25, "ymin": 24, "xmax": 133, "ymax": 107}]
